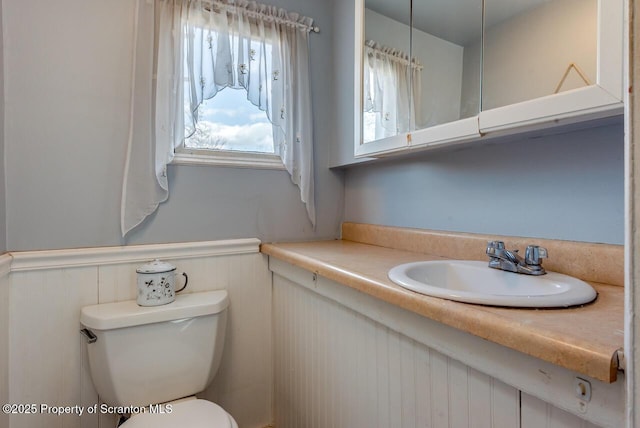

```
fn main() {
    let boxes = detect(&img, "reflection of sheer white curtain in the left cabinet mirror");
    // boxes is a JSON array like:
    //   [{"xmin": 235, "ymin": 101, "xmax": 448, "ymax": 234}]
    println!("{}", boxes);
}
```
[{"xmin": 363, "ymin": 40, "xmax": 422, "ymax": 142}]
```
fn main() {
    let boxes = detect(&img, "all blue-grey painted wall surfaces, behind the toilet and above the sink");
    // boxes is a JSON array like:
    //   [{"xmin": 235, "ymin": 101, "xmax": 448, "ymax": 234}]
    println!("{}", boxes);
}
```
[{"xmin": 0, "ymin": 0, "xmax": 624, "ymax": 251}]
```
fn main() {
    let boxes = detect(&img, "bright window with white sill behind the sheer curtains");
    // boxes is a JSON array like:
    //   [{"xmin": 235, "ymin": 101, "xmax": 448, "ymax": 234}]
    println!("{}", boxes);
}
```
[{"xmin": 176, "ymin": 22, "xmax": 284, "ymax": 169}]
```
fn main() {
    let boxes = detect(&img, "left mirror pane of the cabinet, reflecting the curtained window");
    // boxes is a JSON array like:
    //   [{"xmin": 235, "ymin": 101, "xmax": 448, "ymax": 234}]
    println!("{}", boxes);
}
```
[{"xmin": 362, "ymin": 0, "xmax": 418, "ymax": 143}]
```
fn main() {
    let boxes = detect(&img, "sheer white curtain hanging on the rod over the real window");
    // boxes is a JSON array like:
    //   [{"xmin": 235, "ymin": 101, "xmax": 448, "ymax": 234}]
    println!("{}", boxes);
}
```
[{"xmin": 121, "ymin": 0, "xmax": 316, "ymax": 236}]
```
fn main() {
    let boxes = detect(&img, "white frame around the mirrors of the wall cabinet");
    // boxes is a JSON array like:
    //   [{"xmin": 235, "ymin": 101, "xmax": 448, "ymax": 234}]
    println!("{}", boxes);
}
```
[{"xmin": 354, "ymin": 0, "xmax": 627, "ymax": 158}]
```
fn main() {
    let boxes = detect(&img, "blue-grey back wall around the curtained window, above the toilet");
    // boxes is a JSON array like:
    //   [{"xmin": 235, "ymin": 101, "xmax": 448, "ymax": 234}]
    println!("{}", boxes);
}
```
[{"xmin": 0, "ymin": 0, "xmax": 343, "ymax": 251}]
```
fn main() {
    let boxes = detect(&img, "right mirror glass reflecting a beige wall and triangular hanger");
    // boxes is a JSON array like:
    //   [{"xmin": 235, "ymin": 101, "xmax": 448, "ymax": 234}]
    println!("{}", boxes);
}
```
[{"xmin": 482, "ymin": 0, "xmax": 598, "ymax": 110}]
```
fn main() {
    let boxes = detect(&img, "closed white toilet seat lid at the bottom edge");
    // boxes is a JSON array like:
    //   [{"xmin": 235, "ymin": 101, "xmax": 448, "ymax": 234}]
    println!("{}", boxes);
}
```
[{"xmin": 120, "ymin": 399, "xmax": 238, "ymax": 428}]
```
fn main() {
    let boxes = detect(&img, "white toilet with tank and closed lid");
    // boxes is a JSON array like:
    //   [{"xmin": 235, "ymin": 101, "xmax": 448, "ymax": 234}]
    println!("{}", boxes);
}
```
[{"xmin": 80, "ymin": 290, "xmax": 238, "ymax": 428}]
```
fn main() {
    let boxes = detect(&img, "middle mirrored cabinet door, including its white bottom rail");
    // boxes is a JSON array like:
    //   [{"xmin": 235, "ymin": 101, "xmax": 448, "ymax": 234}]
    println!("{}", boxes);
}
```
[{"xmin": 409, "ymin": 0, "xmax": 483, "ymax": 152}]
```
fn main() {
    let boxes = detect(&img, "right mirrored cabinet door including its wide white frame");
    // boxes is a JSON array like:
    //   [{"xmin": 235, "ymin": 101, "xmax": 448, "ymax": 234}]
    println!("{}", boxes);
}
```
[{"xmin": 479, "ymin": 0, "xmax": 623, "ymax": 133}]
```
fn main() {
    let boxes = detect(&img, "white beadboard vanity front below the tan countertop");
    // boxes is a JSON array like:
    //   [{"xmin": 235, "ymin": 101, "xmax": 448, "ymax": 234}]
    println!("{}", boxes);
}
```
[{"xmin": 270, "ymin": 259, "xmax": 624, "ymax": 428}]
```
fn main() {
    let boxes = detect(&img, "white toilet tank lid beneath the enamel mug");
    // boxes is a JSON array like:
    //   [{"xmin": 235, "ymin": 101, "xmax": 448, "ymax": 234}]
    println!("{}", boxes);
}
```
[{"xmin": 80, "ymin": 290, "xmax": 229, "ymax": 330}]
